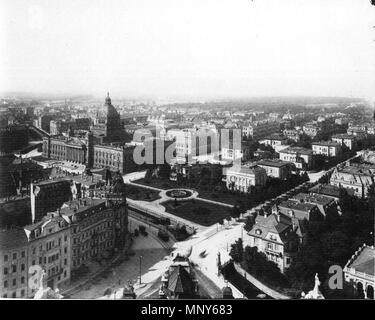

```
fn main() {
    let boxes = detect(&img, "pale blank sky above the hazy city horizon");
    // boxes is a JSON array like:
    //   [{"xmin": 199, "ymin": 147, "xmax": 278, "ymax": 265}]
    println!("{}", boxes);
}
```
[{"xmin": 0, "ymin": 0, "xmax": 375, "ymax": 101}]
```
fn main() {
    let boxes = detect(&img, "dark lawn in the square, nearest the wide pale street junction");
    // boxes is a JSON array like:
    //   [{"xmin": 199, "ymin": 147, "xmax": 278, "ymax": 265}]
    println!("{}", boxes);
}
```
[{"xmin": 162, "ymin": 199, "xmax": 231, "ymax": 226}]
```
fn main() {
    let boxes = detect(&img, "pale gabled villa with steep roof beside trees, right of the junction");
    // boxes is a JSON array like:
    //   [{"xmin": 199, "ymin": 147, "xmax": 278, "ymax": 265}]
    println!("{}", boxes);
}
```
[{"xmin": 247, "ymin": 211, "xmax": 304, "ymax": 272}]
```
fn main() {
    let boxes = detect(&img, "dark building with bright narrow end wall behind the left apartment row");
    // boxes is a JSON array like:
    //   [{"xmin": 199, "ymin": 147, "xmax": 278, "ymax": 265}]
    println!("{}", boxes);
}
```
[{"xmin": 30, "ymin": 180, "xmax": 72, "ymax": 223}]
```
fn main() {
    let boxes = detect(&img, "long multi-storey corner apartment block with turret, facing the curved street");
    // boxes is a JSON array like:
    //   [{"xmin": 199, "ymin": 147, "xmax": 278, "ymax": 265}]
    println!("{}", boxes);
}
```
[{"xmin": 60, "ymin": 191, "xmax": 128, "ymax": 274}]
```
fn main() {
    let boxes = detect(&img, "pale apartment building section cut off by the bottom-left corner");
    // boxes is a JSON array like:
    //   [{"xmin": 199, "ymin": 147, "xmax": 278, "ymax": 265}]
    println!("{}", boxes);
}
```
[{"xmin": 0, "ymin": 228, "xmax": 29, "ymax": 298}]
